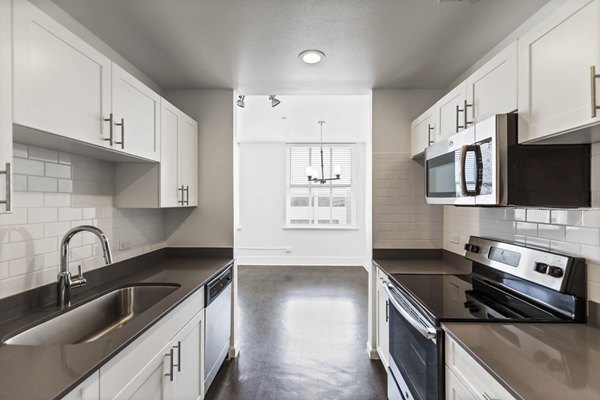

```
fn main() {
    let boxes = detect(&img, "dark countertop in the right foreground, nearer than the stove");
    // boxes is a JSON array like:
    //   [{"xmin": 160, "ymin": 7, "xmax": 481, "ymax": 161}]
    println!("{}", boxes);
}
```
[{"xmin": 443, "ymin": 323, "xmax": 600, "ymax": 400}]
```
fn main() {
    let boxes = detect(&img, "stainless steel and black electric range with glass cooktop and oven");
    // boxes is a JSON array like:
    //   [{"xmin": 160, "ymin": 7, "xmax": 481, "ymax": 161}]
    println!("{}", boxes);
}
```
[{"xmin": 388, "ymin": 236, "xmax": 586, "ymax": 400}]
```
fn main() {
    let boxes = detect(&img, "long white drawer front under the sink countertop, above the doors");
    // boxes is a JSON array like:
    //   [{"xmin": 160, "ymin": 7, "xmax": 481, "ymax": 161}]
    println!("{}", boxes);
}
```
[{"xmin": 100, "ymin": 288, "xmax": 204, "ymax": 399}]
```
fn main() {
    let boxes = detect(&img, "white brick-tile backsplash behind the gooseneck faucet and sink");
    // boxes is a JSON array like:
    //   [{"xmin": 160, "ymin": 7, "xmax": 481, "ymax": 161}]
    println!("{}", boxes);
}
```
[{"xmin": 0, "ymin": 144, "xmax": 165, "ymax": 298}]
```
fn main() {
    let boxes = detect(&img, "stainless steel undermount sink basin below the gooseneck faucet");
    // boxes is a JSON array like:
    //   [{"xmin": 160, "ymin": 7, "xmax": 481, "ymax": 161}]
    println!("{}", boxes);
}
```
[{"xmin": 4, "ymin": 284, "xmax": 179, "ymax": 346}]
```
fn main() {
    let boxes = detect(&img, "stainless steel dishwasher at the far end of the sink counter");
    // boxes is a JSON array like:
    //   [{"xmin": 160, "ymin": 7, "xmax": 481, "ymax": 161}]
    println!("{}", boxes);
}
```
[{"xmin": 204, "ymin": 266, "xmax": 233, "ymax": 393}]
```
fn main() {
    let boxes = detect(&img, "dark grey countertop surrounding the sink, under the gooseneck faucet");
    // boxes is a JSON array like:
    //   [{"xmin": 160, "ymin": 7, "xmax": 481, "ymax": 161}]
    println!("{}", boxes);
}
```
[{"xmin": 0, "ymin": 256, "xmax": 232, "ymax": 400}]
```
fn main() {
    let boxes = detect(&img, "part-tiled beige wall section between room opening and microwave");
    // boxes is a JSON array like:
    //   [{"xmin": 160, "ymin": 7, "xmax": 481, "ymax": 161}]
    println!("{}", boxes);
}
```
[{"xmin": 373, "ymin": 89, "xmax": 443, "ymax": 249}]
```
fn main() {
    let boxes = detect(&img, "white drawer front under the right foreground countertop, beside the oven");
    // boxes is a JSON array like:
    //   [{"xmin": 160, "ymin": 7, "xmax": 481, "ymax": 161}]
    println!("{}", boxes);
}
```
[{"xmin": 446, "ymin": 335, "xmax": 516, "ymax": 400}]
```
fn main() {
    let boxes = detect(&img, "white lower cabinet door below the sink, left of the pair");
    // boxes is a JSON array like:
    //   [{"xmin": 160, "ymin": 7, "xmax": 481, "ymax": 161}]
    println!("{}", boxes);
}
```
[{"xmin": 115, "ymin": 346, "xmax": 175, "ymax": 400}]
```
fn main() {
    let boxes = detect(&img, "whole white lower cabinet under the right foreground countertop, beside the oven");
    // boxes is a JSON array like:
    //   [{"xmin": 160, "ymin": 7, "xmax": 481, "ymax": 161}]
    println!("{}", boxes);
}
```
[{"xmin": 445, "ymin": 335, "xmax": 516, "ymax": 400}]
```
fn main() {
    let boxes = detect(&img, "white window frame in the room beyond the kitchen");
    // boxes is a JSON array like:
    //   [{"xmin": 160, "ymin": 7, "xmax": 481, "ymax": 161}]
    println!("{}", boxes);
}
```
[{"xmin": 283, "ymin": 142, "xmax": 359, "ymax": 230}]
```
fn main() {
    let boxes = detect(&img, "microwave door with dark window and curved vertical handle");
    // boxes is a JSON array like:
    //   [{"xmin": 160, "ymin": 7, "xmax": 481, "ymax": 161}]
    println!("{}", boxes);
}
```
[{"xmin": 425, "ymin": 127, "xmax": 481, "ymax": 205}]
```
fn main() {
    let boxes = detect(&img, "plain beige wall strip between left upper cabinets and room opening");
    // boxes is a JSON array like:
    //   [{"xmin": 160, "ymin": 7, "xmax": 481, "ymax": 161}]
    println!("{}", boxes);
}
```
[{"xmin": 166, "ymin": 90, "xmax": 233, "ymax": 247}]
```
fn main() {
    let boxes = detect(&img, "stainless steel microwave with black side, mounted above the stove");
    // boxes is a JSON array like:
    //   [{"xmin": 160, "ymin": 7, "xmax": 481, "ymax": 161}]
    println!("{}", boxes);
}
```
[{"xmin": 425, "ymin": 114, "xmax": 591, "ymax": 207}]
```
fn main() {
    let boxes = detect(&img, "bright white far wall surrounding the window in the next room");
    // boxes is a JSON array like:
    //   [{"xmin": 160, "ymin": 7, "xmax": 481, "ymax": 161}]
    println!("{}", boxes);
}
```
[{"xmin": 235, "ymin": 95, "xmax": 371, "ymax": 265}]
